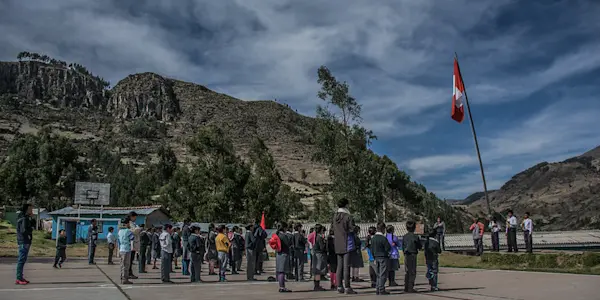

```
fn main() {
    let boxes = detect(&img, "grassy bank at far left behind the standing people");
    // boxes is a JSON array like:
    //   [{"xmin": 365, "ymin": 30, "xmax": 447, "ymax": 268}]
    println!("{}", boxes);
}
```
[{"xmin": 0, "ymin": 221, "xmax": 108, "ymax": 257}]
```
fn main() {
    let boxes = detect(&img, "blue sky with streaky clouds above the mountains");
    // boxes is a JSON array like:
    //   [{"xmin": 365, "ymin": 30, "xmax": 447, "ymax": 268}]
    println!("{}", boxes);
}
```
[{"xmin": 0, "ymin": 0, "xmax": 600, "ymax": 199}]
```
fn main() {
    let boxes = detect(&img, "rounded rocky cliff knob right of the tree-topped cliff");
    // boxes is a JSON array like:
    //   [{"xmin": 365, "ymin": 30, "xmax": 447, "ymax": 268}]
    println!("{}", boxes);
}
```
[{"xmin": 108, "ymin": 73, "xmax": 181, "ymax": 121}]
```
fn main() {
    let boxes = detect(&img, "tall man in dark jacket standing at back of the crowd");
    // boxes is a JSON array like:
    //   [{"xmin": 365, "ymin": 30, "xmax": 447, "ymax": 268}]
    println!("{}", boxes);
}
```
[{"xmin": 331, "ymin": 198, "xmax": 360, "ymax": 294}]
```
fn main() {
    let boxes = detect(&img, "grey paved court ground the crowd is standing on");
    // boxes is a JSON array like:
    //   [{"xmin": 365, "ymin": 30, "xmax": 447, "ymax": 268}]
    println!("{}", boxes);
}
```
[{"xmin": 0, "ymin": 258, "xmax": 600, "ymax": 300}]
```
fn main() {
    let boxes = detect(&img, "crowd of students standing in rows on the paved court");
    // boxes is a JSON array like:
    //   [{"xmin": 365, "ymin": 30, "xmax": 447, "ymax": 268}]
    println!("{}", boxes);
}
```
[{"xmin": 17, "ymin": 199, "xmax": 441, "ymax": 295}]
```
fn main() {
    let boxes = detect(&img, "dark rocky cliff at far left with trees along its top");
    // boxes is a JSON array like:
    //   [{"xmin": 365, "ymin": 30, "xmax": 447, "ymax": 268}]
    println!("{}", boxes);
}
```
[{"xmin": 0, "ymin": 61, "xmax": 106, "ymax": 108}]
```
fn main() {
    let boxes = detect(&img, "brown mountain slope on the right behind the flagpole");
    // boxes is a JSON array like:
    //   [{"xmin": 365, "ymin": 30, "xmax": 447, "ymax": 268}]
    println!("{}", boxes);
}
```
[{"xmin": 468, "ymin": 147, "xmax": 600, "ymax": 230}]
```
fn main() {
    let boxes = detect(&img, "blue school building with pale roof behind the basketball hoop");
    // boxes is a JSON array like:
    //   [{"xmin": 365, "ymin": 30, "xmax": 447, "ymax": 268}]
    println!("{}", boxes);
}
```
[{"xmin": 50, "ymin": 205, "xmax": 171, "ymax": 244}]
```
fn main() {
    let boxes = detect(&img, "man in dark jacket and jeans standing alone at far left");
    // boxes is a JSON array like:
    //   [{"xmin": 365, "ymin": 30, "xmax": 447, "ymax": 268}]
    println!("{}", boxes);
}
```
[{"xmin": 15, "ymin": 203, "xmax": 35, "ymax": 285}]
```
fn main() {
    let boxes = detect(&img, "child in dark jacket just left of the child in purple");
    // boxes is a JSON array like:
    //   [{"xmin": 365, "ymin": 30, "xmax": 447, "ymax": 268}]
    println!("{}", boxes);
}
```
[{"xmin": 371, "ymin": 222, "xmax": 392, "ymax": 295}]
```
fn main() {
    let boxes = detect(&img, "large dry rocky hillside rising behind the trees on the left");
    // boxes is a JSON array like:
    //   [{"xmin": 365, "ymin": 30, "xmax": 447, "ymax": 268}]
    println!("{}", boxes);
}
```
[{"xmin": 0, "ymin": 56, "xmax": 463, "ymax": 230}]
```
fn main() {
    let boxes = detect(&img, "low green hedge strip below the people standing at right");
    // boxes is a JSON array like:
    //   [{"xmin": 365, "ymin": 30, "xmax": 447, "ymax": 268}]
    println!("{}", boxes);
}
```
[{"xmin": 481, "ymin": 252, "xmax": 600, "ymax": 269}]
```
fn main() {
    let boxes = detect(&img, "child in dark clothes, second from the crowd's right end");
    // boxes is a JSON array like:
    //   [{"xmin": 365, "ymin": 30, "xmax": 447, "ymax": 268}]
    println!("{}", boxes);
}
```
[{"xmin": 402, "ymin": 221, "xmax": 423, "ymax": 293}]
